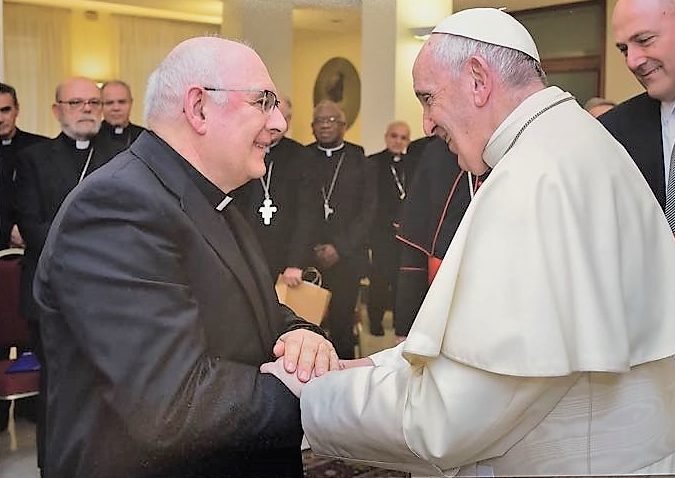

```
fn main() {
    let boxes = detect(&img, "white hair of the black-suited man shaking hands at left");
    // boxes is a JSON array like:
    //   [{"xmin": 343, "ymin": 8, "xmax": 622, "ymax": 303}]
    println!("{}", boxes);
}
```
[{"xmin": 143, "ymin": 37, "xmax": 234, "ymax": 129}]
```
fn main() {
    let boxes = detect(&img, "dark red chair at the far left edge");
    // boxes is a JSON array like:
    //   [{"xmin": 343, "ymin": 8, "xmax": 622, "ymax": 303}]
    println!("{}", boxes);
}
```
[{"xmin": 0, "ymin": 249, "xmax": 40, "ymax": 408}]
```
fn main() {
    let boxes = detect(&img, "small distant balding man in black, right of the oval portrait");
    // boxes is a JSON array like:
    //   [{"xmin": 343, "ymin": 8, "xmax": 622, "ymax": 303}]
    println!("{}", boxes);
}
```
[{"xmin": 368, "ymin": 121, "xmax": 414, "ymax": 335}]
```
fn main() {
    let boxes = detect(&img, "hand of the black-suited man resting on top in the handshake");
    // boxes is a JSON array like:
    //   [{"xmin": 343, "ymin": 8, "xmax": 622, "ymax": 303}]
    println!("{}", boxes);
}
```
[{"xmin": 273, "ymin": 329, "xmax": 340, "ymax": 382}]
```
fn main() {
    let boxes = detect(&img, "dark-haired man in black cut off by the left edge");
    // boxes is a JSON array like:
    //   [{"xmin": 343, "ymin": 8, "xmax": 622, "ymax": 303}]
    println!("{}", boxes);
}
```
[{"xmin": 0, "ymin": 83, "xmax": 47, "ymax": 250}]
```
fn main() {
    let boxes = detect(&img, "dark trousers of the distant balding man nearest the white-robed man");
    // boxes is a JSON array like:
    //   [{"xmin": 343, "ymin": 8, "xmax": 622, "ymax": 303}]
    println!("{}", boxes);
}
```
[{"xmin": 368, "ymin": 235, "xmax": 400, "ymax": 333}]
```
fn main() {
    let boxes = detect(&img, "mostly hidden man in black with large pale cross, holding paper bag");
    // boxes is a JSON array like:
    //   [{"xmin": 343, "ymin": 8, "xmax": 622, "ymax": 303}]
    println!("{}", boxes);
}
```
[{"xmin": 234, "ymin": 97, "xmax": 321, "ymax": 287}]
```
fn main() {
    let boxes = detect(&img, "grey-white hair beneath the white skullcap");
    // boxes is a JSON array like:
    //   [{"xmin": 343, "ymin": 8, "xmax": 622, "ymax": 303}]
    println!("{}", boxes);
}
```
[{"xmin": 428, "ymin": 34, "xmax": 546, "ymax": 88}]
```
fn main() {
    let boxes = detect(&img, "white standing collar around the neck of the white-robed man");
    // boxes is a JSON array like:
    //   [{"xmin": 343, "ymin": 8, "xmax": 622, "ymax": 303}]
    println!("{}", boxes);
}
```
[{"xmin": 483, "ymin": 86, "xmax": 573, "ymax": 169}]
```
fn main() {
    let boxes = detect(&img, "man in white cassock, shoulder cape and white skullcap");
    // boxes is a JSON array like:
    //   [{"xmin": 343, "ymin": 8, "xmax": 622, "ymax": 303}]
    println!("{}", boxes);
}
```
[{"xmin": 263, "ymin": 9, "xmax": 675, "ymax": 476}]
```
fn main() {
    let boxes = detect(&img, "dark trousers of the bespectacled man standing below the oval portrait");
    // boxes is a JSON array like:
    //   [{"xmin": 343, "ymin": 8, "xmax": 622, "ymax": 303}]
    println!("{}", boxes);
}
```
[{"xmin": 321, "ymin": 259, "xmax": 361, "ymax": 359}]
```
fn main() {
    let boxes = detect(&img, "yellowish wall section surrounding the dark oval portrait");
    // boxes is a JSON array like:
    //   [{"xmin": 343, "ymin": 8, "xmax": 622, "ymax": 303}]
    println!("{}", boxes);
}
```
[{"xmin": 291, "ymin": 30, "xmax": 361, "ymax": 144}]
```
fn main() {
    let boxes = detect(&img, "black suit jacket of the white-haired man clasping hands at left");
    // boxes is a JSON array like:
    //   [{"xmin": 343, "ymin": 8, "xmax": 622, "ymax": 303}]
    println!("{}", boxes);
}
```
[{"xmin": 35, "ymin": 132, "xmax": 324, "ymax": 478}]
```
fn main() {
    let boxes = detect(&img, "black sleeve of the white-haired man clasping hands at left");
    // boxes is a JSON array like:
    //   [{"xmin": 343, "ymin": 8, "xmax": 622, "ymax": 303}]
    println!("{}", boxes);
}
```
[{"xmin": 36, "ymin": 178, "xmax": 301, "ymax": 457}]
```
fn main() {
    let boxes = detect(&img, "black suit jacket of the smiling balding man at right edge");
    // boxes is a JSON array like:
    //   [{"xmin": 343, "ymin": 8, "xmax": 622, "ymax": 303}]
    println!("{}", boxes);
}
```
[{"xmin": 598, "ymin": 93, "xmax": 666, "ymax": 208}]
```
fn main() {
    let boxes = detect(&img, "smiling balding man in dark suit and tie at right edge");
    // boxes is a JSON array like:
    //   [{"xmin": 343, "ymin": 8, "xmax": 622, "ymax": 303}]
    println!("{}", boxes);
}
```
[{"xmin": 599, "ymin": 0, "xmax": 675, "ymax": 232}]
